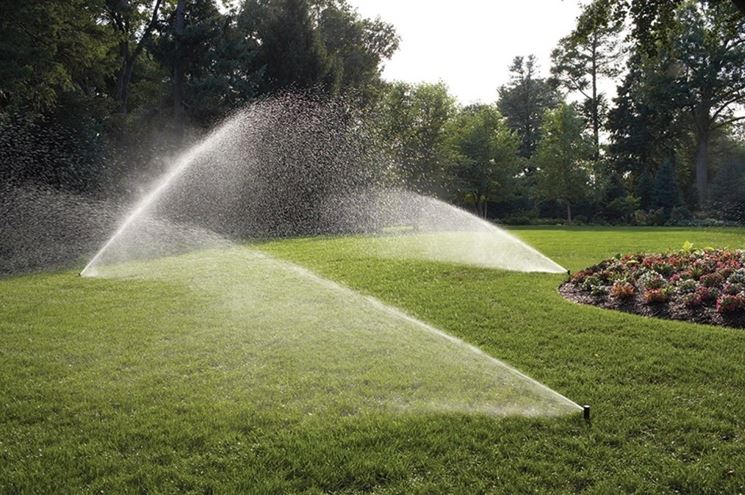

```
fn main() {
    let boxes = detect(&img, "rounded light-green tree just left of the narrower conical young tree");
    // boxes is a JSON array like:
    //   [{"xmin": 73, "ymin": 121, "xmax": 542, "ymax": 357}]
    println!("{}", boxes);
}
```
[{"xmin": 444, "ymin": 105, "xmax": 520, "ymax": 218}]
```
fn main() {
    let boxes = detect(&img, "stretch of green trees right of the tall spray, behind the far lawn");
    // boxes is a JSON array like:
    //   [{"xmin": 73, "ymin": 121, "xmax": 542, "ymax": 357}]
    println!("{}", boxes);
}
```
[{"xmin": 383, "ymin": 0, "xmax": 745, "ymax": 225}]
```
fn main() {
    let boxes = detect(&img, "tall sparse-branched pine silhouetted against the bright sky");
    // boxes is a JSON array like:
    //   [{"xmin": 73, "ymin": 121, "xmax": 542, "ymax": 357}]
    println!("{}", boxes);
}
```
[{"xmin": 551, "ymin": 0, "xmax": 623, "ymax": 162}]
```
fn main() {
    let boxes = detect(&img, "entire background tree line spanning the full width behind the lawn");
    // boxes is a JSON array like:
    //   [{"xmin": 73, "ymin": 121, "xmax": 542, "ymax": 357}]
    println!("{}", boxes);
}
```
[{"xmin": 0, "ymin": 0, "xmax": 745, "ymax": 224}]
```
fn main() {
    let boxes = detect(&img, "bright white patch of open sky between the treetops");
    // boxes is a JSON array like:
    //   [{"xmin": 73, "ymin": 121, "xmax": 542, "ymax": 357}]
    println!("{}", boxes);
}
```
[{"xmin": 348, "ymin": 0, "xmax": 580, "ymax": 104}]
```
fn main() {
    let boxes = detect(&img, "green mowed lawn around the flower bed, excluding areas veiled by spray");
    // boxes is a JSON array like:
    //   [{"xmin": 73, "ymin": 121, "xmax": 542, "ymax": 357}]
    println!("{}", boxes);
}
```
[{"xmin": 0, "ymin": 228, "xmax": 745, "ymax": 493}]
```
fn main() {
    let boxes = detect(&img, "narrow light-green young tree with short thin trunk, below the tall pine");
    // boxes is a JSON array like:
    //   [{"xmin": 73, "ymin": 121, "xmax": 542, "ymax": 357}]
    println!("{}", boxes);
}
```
[{"xmin": 534, "ymin": 103, "xmax": 593, "ymax": 223}]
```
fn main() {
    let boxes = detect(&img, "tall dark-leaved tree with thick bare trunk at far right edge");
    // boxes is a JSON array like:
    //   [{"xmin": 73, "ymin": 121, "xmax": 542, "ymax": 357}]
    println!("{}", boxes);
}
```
[{"xmin": 661, "ymin": 0, "xmax": 745, "ymax": 207}]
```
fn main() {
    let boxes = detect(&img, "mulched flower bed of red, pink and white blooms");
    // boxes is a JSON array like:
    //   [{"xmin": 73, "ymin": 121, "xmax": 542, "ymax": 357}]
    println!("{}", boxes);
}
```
[{"xmin": 559, "ymin": 245, "xmax": 745, "ymax": 327}]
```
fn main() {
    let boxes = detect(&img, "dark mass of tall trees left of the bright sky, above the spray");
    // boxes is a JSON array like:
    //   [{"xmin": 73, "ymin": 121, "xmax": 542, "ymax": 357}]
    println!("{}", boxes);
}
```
[{"xmin": 0, "ymin": 0, "xmax": 398, "ymax": 198}]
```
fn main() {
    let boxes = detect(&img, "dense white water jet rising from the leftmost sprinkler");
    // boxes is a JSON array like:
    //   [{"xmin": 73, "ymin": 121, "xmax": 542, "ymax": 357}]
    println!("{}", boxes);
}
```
[{"xmin": 80, "ymin": 119, "xmax": 231, "ymax": 277}]
